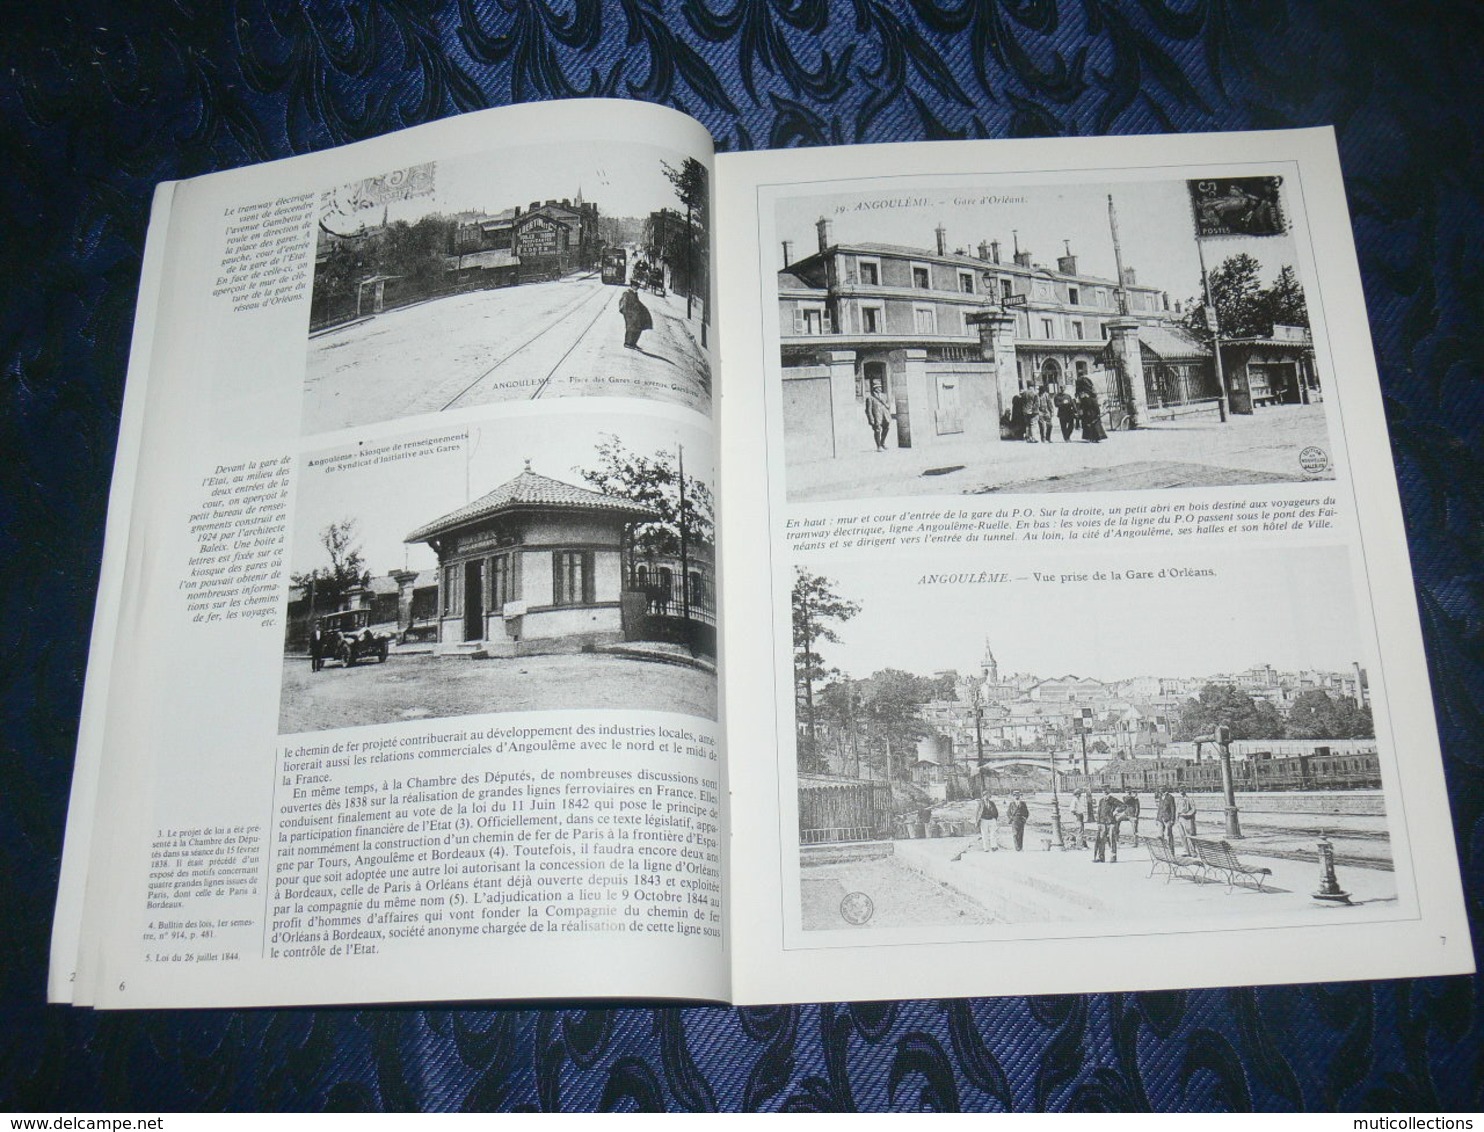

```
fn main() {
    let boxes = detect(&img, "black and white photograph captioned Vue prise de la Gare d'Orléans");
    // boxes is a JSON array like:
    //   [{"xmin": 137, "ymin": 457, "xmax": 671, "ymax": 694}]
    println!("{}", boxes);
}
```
[{"xmin": 791, "ymin": 547, "xmax": 1398, "ymax": 938}]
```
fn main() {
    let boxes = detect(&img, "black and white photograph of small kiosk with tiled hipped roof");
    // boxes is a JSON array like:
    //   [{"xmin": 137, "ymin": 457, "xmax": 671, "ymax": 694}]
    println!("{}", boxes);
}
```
[{"xmin": 279, "ymin": 417, "xmax": 717, "ymax": 734}]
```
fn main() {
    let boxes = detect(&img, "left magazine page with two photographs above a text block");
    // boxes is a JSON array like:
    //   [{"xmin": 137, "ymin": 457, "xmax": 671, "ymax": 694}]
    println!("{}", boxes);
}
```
[{"xmin": 52, "ymin": 101, "xmax": 729, "ymax": 1007}]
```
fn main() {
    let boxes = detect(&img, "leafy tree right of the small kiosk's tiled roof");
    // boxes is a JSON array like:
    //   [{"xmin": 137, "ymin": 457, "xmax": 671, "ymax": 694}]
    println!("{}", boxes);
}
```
[{"xmin": 577, "ymin": 433, "xmax": 715, "ymax": 568}]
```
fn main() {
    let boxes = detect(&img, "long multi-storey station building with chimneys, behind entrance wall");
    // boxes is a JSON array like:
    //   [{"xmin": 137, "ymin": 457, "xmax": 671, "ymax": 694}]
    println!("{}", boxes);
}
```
[{"xmin": 778, "ymin": 218, "xmax": 1318, "ymax": 461}]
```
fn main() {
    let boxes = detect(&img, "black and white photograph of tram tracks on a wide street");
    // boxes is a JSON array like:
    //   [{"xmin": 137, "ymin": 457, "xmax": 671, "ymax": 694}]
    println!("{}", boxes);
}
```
[{"xmin": 303, "ymin": 141, "xmax": 711, "ymax": 435}]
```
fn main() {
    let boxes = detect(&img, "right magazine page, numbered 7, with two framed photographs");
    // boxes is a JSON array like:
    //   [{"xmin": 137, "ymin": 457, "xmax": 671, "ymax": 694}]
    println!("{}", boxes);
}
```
[{"xmin": 717, "ymin": 131, "xmax": 1472, "ymax": 1003}]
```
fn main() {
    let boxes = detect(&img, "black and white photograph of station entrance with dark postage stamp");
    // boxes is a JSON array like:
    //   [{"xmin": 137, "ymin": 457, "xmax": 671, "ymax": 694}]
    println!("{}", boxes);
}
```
[{"xmin": 773, "ymin": 174, "xmax": 1334, "ymax": 503}]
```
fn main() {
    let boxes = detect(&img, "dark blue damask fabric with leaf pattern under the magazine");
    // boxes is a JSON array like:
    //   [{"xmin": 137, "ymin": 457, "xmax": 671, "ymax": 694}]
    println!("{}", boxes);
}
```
[{"xmin": 0, "ymin": 0, "xmax": 1484, "ymax": 1111}]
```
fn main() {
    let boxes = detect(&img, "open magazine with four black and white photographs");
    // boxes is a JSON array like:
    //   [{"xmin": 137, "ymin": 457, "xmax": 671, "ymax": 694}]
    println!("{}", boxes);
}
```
[{"xmin": 49, "ymin": 101, "xmax": 1472, "ymax": 1007}]
